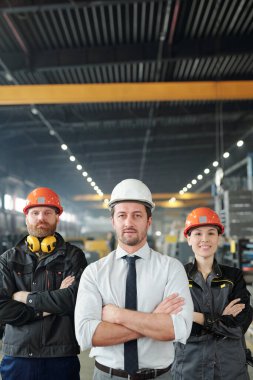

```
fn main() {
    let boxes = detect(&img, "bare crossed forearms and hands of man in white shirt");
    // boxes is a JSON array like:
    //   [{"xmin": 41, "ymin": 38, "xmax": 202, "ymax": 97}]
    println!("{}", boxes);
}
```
[{"xmin": 92, "ymin": 293, "xmax": 184, "ymax": 346}]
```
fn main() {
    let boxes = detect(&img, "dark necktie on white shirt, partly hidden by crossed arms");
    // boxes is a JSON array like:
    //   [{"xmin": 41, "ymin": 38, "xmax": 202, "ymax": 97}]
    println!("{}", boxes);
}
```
[{"xmin": 124, "ymin": 255, "xmax": 139, "ymax": 375}]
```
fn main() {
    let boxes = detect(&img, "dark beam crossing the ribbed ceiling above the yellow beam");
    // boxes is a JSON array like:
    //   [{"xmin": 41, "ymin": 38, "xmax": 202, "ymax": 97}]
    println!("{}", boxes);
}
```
[{"xmin": 1, "ymin": 36, "xmax": 252, "ymax": 72}]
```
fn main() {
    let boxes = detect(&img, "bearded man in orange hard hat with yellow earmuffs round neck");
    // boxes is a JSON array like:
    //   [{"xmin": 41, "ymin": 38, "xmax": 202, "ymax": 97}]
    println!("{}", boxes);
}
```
[{"xmin": 0, "ymin": 187, "xmax": 87, "ymax": 380}]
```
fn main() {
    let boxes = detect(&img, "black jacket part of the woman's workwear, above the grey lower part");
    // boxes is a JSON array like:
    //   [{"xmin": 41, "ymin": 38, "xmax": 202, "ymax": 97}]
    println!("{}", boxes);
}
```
[{"xmin": 185, "ymin": 260, "xmax": 252, "ymax": 337}]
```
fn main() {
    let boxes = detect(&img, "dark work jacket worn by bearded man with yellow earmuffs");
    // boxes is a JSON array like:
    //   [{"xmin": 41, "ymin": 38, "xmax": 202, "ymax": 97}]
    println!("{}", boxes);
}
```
[{"xmin": 0, "ymin": 233, "xmax": 87, "ymax": 358}]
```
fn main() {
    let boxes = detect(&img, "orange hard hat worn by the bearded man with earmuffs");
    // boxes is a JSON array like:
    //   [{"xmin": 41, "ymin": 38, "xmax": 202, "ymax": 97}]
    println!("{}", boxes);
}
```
[{"xmin": 23, "ymin": 187, "xmax": 63, "ymax": 215}]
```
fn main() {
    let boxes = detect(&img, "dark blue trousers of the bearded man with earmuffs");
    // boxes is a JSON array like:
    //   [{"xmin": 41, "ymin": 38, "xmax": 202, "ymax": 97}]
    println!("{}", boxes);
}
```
[{"xmin": 0, "ymin": 356, "xmax": 80, "ymax": 380}]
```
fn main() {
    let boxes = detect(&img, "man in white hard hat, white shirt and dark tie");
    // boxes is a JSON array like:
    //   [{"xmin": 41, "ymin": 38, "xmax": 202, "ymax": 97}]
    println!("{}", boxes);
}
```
[{"xmin": 75, "ymin": 179, "xmax": 193, "ymax": 380}]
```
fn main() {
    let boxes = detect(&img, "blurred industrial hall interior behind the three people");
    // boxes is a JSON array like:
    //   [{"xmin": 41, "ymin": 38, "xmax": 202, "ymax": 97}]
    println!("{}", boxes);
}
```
[{"xmin": 0, "ymin": 0, "xmax": 253, "ymax": 376}]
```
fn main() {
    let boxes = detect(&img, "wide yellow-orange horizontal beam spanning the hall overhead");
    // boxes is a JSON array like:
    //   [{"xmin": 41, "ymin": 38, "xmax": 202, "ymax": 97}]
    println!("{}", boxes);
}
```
[{"xmin": 0, "ymin": 81, "xmax": 253, "ymax": 105}]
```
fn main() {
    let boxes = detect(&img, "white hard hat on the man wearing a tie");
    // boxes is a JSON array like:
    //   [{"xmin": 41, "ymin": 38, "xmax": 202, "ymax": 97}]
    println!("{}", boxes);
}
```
[{"xmin": 108, "ymin": 178, "xmax": 155, "ymax": 210}]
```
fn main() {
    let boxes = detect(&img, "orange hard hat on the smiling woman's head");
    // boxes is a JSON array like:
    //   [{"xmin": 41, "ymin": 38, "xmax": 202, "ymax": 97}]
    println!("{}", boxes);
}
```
[{"xmin": 184, "ymin": 207, "xmax": 224, "ymax": 237}]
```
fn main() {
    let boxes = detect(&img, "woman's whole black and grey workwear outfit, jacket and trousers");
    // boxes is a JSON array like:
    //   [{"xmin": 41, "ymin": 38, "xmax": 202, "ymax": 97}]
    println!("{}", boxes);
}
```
[{"xmin": 172, "ymin": 261, "xmax": 252, "ymax": 380}]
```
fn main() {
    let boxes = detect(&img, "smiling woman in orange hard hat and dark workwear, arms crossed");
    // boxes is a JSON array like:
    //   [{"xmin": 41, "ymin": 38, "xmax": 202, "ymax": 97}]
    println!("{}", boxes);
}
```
[{"xmin": 172, "ymin": 207, "xmax": 252, "ymax": 380}]
